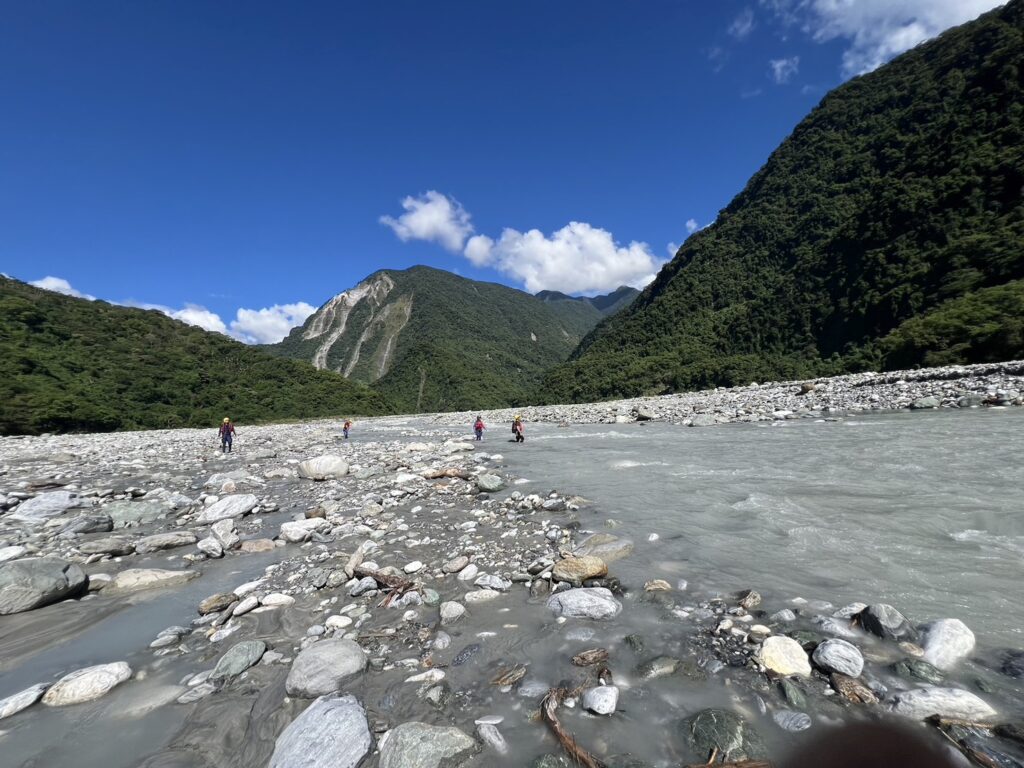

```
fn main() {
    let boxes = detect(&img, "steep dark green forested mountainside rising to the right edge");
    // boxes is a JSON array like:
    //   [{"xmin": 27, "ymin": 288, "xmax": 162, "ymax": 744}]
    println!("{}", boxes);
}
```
[{"xmin": 542, "ymin": 0, "xmax": 1024, "ymax": 401}]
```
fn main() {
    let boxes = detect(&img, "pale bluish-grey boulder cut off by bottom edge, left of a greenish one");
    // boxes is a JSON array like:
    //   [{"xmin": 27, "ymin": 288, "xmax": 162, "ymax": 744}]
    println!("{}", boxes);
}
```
[{"xmin": 269, "ymin": 695, "xmax": 373, "ymax": 768}]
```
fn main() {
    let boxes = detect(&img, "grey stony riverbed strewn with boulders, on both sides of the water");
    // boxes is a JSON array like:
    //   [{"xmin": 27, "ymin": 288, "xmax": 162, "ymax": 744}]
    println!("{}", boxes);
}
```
[{"xmin": 0, "ymin": 364, "xmax": 1024, "ymax": 768}]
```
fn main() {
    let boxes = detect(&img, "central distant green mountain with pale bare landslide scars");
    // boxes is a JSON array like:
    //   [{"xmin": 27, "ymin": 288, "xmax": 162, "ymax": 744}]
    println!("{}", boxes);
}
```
[{"xmin": 269, "ymin": 266, "xmax": 632, "ymax": 412}]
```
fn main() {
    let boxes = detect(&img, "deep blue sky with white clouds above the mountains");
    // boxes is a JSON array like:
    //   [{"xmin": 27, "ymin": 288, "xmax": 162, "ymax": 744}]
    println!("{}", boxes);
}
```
[{"xmin": 0, "ymin": 0, "xmax": 1000, "ymax": 341}]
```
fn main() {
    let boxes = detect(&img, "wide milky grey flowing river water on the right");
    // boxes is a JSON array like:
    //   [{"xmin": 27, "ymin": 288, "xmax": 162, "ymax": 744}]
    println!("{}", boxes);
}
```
[{"xmin": 507, "ymin": 411, "xmax": 1024, "ymax": 647}]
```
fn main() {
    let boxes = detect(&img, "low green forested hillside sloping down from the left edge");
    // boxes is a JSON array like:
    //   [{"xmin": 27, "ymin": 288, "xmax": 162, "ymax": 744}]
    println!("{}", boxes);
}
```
[{"xmin": 0, "ymin": 278, "xmax": 387, "ymax": 434}]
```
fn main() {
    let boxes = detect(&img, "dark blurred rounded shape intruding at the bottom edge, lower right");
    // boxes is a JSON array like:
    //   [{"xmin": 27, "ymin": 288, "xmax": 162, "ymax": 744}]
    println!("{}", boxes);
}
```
[{"xmin": 779, "ymin": 723, "xmax": 956, "ymax": 768}]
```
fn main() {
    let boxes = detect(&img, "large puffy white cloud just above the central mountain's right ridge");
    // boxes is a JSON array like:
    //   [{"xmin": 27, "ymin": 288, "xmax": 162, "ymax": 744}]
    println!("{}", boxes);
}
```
[{"xmin": 456, "ymin": 221, "xmax": 665, "ymax": 293}]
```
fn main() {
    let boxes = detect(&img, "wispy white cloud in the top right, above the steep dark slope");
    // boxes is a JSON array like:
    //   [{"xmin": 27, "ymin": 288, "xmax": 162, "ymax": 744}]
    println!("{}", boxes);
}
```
[{"xmin": 760, "ymin": 0, "xmax": 1006, "ymax": 77}]
